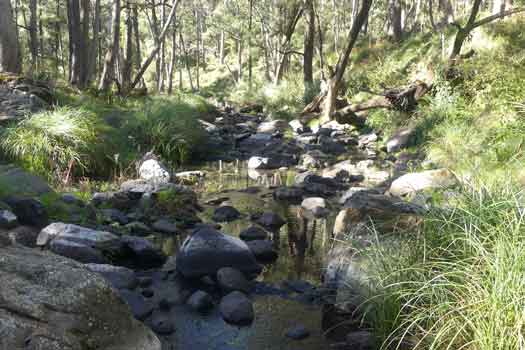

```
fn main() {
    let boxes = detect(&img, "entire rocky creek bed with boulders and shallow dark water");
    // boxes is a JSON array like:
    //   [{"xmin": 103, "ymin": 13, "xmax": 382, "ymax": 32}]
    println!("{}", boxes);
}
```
[{"xmin": 0, "ymin": 110, "xmax": 455, "ymax": 349}]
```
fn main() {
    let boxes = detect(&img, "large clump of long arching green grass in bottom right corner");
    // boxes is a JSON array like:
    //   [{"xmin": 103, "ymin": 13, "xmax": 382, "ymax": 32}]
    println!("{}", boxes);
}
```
[{"xmin": 363, "ymin": 186, "xmax": 525, "ymax": 350}]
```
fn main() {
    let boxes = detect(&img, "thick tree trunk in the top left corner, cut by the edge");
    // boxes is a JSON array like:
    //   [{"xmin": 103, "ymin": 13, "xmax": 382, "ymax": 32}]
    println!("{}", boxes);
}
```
[{"xmin": 0, "ymin": 0, "xmax": 22, "ymax": 73}]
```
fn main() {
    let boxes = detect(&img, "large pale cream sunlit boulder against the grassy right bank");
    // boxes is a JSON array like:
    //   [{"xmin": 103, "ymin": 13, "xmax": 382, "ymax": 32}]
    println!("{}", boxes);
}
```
[{"xmin": 389, "ymin": 169, "xmax": 458, "ymax": 196}]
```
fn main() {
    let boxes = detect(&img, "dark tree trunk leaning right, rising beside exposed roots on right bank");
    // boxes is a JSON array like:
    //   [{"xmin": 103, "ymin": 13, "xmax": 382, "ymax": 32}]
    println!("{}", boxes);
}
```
[{"xmin": 323, "ymin": 0, "xmax": 372, "ymax": 120}]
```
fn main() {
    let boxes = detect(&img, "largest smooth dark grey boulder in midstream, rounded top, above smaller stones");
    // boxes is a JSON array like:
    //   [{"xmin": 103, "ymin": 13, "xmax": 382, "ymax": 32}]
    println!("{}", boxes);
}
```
[{"xmin": 177, "ymin": 227, "xmax": 261, "ymax": 278}]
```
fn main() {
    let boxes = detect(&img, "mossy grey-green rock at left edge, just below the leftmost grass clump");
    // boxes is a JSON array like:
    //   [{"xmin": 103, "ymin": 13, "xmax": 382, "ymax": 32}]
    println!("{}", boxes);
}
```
[{"xmin": 0, "ymin": 164, "xmax": 53, "ymax": 197}]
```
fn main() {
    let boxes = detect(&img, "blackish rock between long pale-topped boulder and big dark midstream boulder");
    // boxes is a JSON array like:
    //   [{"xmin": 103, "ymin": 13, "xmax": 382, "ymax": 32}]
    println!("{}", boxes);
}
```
[{"xmin": 121, "ymin": 236, "xmax": 166, "ymax": 269}]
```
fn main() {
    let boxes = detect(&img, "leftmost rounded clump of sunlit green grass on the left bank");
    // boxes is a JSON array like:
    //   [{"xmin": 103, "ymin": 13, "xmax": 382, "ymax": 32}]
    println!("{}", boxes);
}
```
[{"xmin": 0, "ymin": 107, "xmax": 105, "ymax": 179}]
